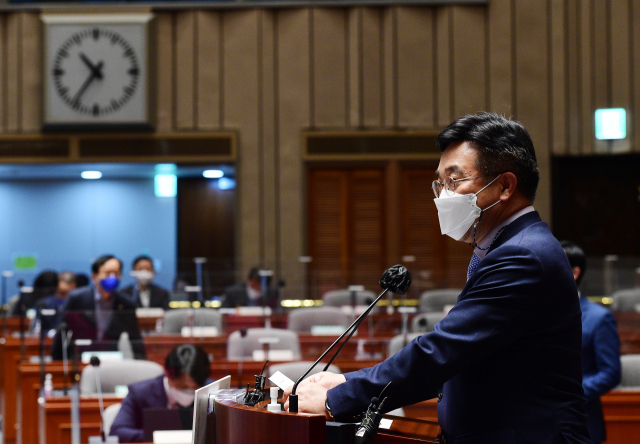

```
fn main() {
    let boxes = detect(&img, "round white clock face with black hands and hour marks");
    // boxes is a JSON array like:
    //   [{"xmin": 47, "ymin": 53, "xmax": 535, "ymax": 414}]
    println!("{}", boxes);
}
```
[{"xmin": 51, "ymin": 26, "xmax": 140, "ymax": 117}]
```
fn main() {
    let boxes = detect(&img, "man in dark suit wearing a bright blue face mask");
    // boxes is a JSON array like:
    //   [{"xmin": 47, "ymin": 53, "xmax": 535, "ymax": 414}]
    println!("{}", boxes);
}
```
[{"xmin": 51, "ymin": 255, "xmax": 145, "ymax": 360}]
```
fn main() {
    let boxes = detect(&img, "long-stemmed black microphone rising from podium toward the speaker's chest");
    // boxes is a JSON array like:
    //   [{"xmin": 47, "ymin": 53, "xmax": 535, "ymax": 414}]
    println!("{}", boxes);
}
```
[{"xmin": 289, "ymin": 265, "xmax": 411, "ymax": 413}]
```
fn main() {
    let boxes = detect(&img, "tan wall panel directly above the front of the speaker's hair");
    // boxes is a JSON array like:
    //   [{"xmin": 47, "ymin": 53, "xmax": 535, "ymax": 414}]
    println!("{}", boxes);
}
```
[{"xmin": 452, "ymin": 6, "xmax": 487, "ymax": 118}]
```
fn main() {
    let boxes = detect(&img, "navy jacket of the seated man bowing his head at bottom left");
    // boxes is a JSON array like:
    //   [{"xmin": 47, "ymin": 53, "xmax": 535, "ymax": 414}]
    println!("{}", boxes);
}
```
[{"xmin": 109, "ymin": 375, "xmax": 168, "ymax": 442}]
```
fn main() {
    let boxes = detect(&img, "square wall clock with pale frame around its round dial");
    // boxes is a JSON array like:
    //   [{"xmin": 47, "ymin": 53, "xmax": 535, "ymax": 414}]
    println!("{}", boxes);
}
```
[{"xmin": 42, "ymin": 14, "xmax": 153, "ymax": 131}]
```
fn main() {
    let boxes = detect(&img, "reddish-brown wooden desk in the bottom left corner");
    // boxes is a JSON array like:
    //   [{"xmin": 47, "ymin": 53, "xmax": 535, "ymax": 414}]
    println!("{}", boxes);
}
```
[{"xmin": 37, "ymin": 396, "xmax": 122, "ymax": 444}]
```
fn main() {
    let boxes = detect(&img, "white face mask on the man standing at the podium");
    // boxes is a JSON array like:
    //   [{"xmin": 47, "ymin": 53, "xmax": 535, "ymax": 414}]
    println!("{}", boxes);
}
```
[{"xmin": 433, "ymin": 174, "xmax": 501, "ymax": 240}]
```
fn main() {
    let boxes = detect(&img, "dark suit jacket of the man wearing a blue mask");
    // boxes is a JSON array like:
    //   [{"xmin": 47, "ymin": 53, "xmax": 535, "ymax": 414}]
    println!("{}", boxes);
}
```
[{"xmin": 51, "ymin": 286, "xmax": 145, "ymax": 360}]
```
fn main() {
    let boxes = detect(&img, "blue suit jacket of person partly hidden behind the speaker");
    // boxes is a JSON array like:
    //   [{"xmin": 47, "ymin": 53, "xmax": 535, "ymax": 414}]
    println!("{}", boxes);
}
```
[{"xmin": 580, "ymin": 296, "xmax": 621, "ymax": 443}]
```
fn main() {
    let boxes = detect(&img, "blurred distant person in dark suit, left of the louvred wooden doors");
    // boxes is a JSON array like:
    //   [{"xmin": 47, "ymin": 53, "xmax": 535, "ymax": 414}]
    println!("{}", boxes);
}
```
[{"xmin": 221, "ymin": 267, "xmax": 278, "ymax": 308}]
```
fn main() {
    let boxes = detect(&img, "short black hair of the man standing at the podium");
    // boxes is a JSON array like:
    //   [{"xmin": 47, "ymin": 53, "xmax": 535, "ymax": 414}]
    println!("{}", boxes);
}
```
[{"xmin": 436, "ymin": 112, "xmax": 540, "ymax": 202}]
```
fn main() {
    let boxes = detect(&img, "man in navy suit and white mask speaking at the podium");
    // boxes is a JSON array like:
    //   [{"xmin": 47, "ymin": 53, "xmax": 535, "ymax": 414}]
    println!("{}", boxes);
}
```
[{"xmin": 285, "ymin": 113, "xmax": 590, "ymax": 444}]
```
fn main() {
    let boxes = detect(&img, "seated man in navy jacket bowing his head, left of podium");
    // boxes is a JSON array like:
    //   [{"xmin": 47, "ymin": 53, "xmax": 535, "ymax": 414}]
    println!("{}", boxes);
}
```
[{"xmin": 110, "ymin": 344, "xmax": 211, "ymax": 442}]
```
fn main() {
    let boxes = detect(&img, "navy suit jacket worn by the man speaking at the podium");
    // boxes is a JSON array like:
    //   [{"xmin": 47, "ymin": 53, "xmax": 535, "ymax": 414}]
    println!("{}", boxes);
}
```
[{"xmin": 327, "ymin": 212, "xmax": 590, "ymax": 444}]
